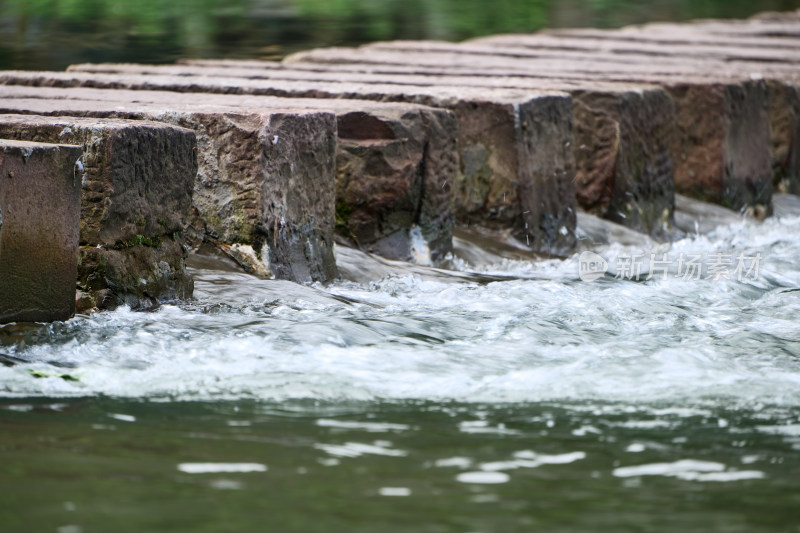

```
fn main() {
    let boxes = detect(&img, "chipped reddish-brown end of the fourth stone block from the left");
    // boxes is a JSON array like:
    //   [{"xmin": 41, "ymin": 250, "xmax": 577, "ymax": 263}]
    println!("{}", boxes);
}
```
[{"xmin": 336, "ymin": 108, "xmax": 458, "ymax": 264}]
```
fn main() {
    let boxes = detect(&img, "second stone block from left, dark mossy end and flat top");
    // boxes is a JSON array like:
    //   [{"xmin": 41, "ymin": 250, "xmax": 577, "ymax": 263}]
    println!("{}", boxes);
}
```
[{"xmin": 0, "ymin": 115, "xmax": 197, "ymax": 309}]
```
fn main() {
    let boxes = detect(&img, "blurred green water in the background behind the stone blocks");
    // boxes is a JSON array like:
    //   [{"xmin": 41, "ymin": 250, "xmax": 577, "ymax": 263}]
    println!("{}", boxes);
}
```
[{"xmin": 0, "ymin": 0, "xmax": 800, "ymax": 69}]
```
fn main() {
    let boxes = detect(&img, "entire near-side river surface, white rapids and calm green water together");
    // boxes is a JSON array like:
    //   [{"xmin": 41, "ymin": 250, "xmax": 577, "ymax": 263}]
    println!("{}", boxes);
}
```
[{"xmin": 0, "ymin": 199, "xmax": 800, "ymax": 533}]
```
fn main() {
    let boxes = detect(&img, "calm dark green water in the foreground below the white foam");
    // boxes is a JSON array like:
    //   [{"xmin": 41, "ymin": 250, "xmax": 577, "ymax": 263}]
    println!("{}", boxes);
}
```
[{"xmin": 0, "ymin": 399, "xmax": 800, "ymax": 533}]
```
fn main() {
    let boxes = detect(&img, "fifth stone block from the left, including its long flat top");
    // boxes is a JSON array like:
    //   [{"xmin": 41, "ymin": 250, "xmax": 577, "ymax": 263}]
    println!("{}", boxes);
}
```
[{"xmin": 0, "ymin": 72, "xmax": 575, "ymax": 254}]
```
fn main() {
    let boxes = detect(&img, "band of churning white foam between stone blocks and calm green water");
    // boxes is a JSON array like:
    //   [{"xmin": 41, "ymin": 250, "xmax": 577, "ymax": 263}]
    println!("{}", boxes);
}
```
[{"xmin": 0, "ymin": 209, "xmax": 800, "ymax": 408}]
